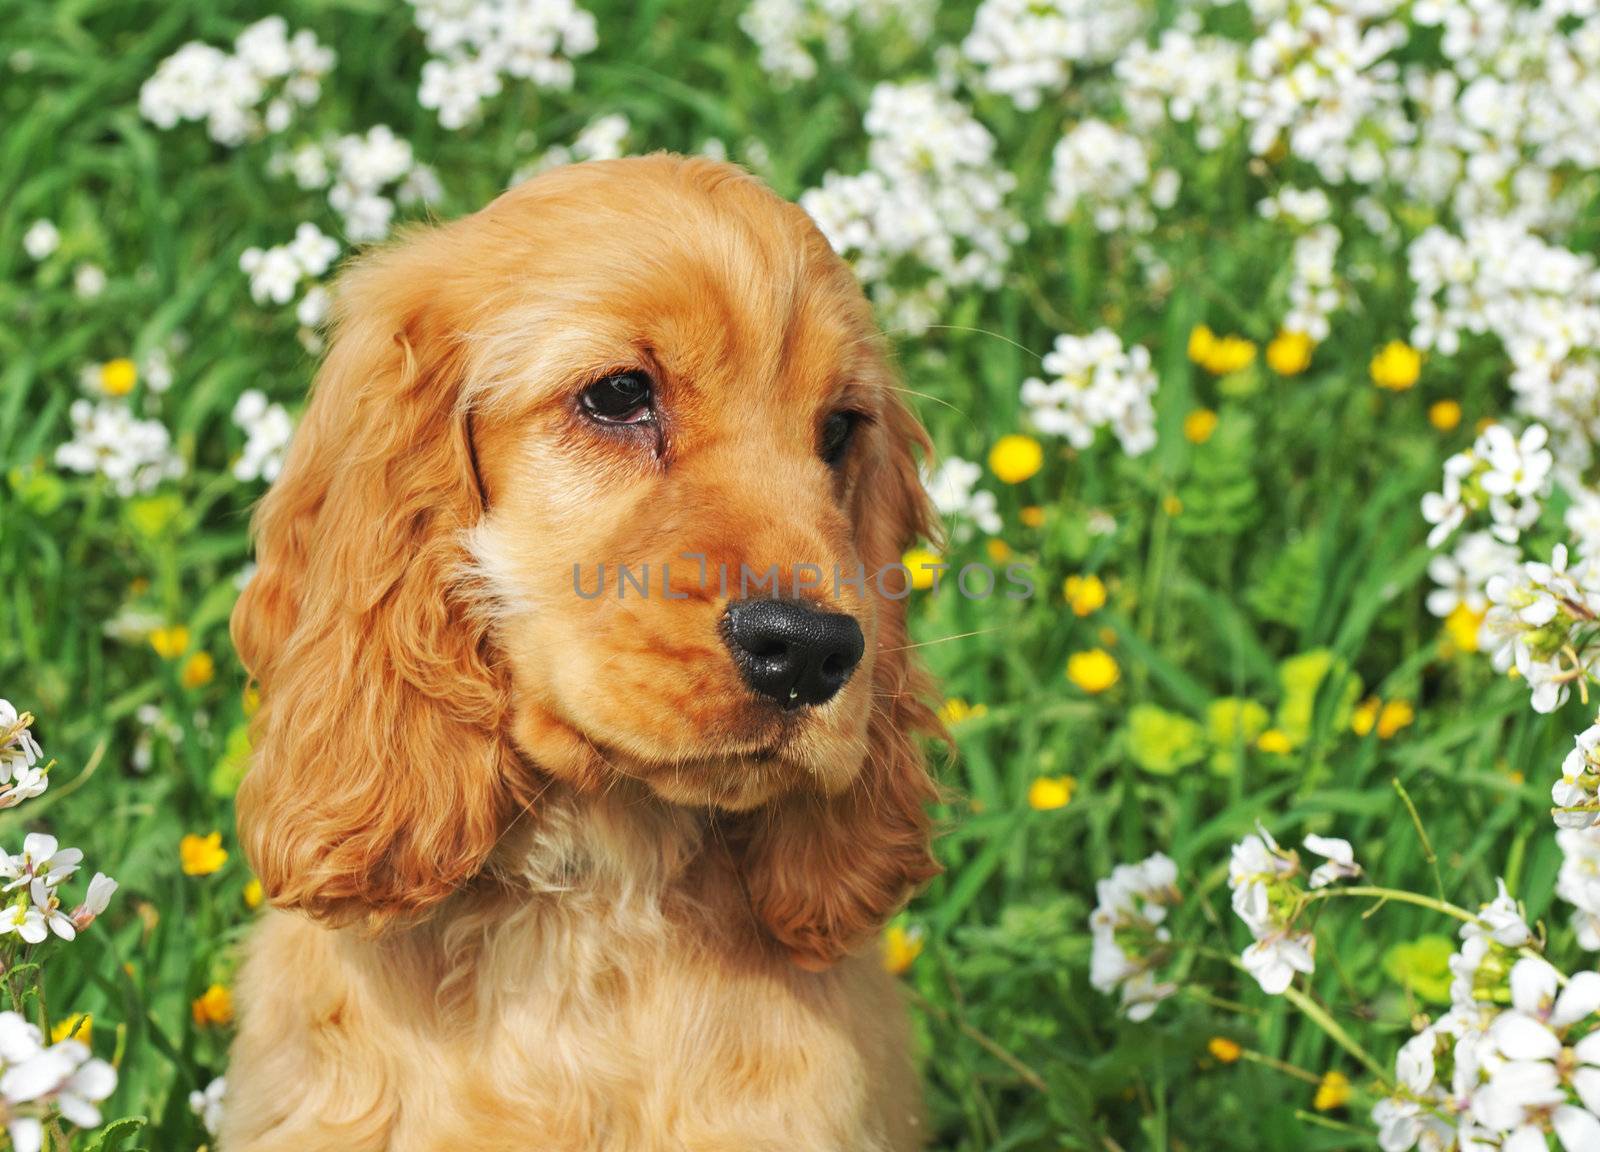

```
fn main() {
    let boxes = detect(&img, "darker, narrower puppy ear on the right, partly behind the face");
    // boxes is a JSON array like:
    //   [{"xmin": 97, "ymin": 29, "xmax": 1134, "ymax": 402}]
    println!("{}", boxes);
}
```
[{"xmin": 741, "ymin": 392, "xmax": 941, "ymax": 968}]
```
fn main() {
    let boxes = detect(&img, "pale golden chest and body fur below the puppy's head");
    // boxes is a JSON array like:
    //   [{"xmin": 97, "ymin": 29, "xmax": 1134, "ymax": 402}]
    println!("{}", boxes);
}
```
[{"xmin": 221, "ymin": 802, "xmax": 918, "ymax": 1152}]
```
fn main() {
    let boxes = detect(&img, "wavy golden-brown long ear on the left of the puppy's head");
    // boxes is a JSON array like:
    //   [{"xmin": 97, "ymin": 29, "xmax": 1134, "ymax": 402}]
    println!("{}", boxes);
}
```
[{"xmin": 232, "ymin": 234, "xmax": 514, "ymax": 923}]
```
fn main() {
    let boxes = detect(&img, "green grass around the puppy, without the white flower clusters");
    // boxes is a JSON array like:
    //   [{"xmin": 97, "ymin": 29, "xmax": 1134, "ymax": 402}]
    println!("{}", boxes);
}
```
[{"xmin": 0, "ymin": 0, "xmax": 1582, "ymax": 1152}]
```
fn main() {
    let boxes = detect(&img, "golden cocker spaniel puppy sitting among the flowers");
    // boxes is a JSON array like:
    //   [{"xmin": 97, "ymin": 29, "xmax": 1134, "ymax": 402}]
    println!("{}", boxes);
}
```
[{"xmin": 221, "ymin": 155, "xmax": 936, "ymax": 1152}]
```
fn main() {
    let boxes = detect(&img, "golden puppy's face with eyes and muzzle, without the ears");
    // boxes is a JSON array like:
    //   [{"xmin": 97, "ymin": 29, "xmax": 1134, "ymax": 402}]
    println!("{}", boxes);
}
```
[{"xmin": 472, "ymin": 171, "xmax": 906, "ymax": 808}]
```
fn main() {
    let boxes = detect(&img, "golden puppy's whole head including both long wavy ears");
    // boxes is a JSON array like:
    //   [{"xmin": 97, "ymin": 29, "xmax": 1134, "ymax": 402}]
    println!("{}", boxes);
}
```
[{"xmin": 234, "ymin": 155, "xmax": 934, "ymax": 963}]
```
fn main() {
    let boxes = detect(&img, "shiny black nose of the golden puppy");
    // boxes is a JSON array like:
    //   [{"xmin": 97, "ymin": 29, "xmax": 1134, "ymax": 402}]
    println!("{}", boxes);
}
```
[{"xmin": 723, "ymin": 600, "xmax": 866, "ymax": 709}]
